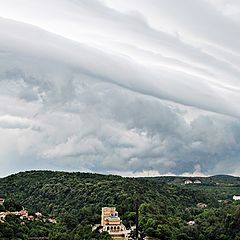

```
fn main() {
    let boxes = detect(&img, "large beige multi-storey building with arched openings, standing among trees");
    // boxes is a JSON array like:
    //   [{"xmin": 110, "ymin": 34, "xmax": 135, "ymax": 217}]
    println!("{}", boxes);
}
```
[{"xmin": 101, "ymin": 207, "xmax": 128, "ymax": 240}]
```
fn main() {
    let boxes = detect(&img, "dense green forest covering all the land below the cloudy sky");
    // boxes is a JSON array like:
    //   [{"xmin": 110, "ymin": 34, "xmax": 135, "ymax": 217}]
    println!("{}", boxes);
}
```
[{"xmin": 0, "ymin": 171, "xmax": 240, "ymax": 240}]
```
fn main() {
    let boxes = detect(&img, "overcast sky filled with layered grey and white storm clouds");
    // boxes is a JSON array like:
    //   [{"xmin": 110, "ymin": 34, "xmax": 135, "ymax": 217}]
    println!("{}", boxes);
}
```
[{"xmin": 0, "ymin": 0, "xmax": 240, "ymax": 175}]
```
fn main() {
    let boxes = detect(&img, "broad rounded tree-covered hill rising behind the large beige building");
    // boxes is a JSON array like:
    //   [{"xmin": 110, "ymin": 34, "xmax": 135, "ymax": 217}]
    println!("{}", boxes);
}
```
[{"xmin": 0, "ymin": 171, "xmax": 216, "ymax": 217}]
